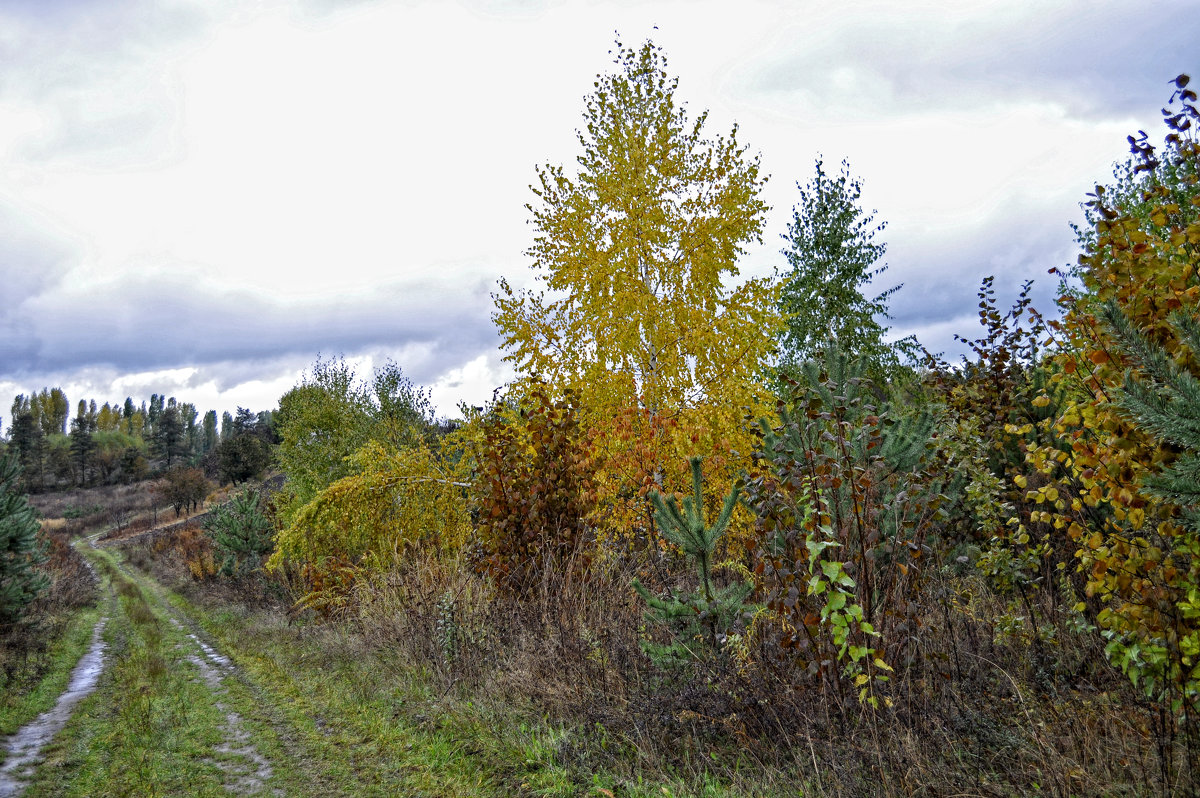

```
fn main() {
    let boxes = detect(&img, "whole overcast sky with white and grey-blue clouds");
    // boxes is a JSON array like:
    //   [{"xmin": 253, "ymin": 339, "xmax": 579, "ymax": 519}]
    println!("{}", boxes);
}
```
[{"xmin": 0, "ymin": 0, "xmax": 1200, "ymax": 422}]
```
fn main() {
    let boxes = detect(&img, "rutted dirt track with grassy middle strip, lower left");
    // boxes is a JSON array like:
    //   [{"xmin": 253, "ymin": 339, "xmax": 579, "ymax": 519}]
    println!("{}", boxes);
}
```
[{"xmin": 0, "ymin": 536, "xmax": 295, "ymax": 797}]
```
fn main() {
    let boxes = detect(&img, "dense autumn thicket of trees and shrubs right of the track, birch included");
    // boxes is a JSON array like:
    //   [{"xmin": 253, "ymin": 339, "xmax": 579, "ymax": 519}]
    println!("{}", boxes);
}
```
[{"xmin": 243, "ymin": 43, "xmax": 1200, "ymax": 794}]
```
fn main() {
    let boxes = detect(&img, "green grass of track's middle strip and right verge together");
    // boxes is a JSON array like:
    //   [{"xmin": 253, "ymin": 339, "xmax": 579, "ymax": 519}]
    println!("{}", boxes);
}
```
[{"xmin": 11, "ymin": 537, "xmax": 797, "ymax": 798}]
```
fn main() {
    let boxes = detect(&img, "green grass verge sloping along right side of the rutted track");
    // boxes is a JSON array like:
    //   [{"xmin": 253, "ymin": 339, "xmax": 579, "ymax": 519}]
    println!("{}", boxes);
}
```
[{"xmin": 173, "ymin": 596, "xmax": 802, "ymax": 798}]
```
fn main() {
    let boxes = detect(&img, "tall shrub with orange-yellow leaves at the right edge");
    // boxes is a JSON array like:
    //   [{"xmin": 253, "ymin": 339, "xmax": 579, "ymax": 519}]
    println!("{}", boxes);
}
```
[{"xmin": 1014, "ymin": 76, "xmax": 1200, "ymax": 758}]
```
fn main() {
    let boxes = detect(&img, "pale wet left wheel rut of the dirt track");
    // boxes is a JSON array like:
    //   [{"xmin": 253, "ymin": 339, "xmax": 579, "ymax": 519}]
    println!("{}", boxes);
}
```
[{"xmin": 0, "ymin": 618, "xmax": 107, "ymax": 798}]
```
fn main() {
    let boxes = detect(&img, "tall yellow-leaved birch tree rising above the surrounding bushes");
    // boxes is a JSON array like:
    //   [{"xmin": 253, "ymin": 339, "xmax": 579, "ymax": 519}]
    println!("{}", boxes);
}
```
[{"xmin": 492, "ymin": 41, "xmax": 780, "ymax": 547}]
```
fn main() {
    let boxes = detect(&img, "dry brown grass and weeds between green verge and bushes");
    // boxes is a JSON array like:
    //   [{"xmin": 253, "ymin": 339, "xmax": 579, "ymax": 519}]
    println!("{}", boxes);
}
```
[{"xmin": 110, "ymin": 506, "xmax": 1195, "ymax": 796}]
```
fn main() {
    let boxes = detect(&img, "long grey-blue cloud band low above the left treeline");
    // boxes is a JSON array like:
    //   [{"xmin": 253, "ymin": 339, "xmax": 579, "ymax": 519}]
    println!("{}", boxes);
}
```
[{"xmin": 0, "ymin": 268, "xmax": 497, "ymax": 383}]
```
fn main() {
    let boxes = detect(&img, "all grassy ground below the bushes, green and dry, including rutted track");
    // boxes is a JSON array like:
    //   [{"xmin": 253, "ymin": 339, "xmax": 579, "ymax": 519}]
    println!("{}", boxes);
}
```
[{"xmin": 7, "ymin": 480, "xmax": 1187, "ymax": 798}]
